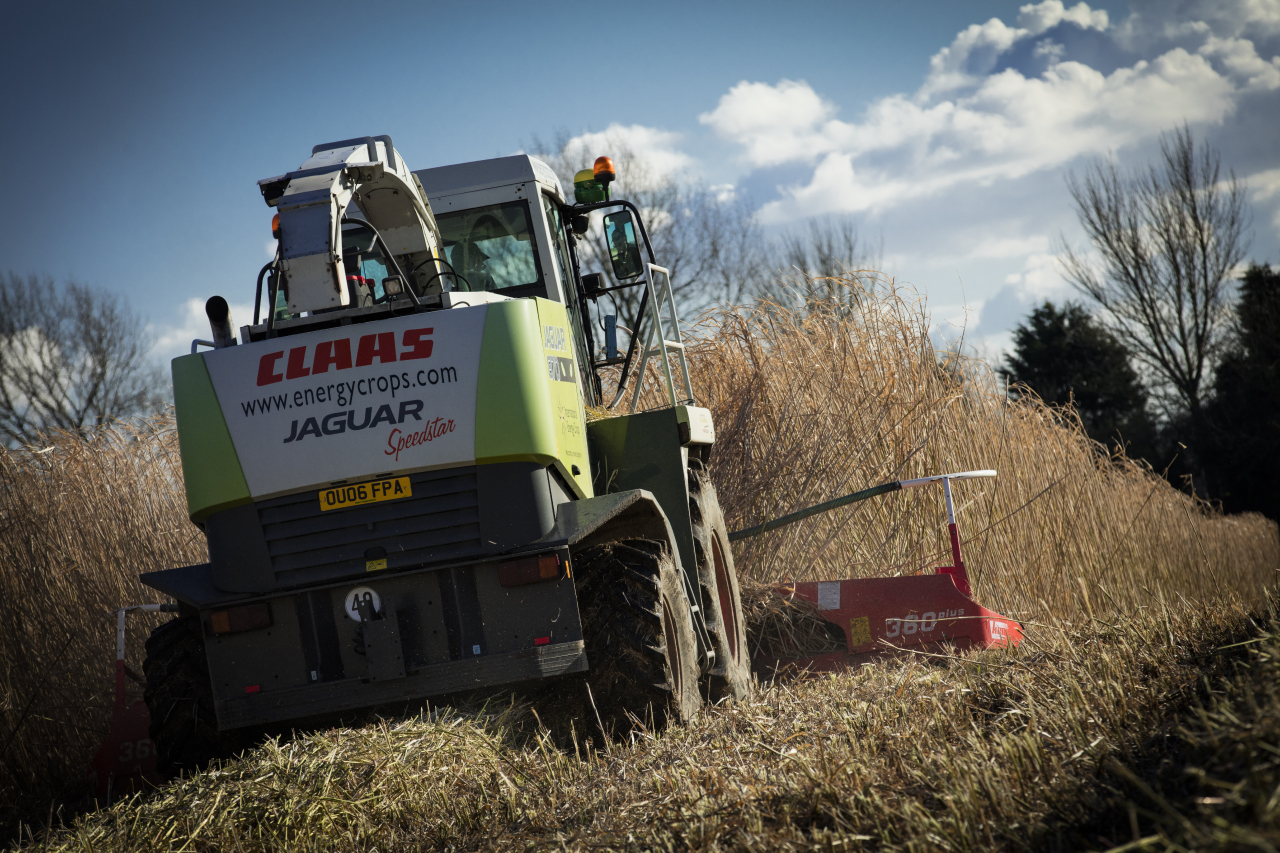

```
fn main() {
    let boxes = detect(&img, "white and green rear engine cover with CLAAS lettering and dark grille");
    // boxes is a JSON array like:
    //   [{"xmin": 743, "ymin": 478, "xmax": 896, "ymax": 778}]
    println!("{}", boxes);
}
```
[{"xmin": 174, "ymin": 298, "xmax": 593, "ymax": 592}]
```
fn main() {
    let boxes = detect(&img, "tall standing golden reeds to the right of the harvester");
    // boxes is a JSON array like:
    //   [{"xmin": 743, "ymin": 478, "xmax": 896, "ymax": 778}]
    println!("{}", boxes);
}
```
[{"xmin": 627, "ymin": 274, "xmax": 1280, "ymax": 620}]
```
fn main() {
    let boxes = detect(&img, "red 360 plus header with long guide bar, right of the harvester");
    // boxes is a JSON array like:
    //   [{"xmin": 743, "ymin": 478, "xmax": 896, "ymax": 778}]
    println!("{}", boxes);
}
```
[{"xmin": 730, "ymin": 470, "xmax": 1023, "ymax": 672}]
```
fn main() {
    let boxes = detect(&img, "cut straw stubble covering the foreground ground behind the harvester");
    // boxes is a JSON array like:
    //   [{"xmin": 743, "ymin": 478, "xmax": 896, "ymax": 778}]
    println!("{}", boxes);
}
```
[{"xmin": 15, "ymin": 594, "xmax": 1280, "ymax": 853}]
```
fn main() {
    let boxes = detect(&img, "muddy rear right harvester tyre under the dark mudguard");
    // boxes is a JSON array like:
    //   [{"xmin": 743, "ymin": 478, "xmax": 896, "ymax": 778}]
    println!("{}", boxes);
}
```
[{"xmin": 573, "ymin": 539, "xmax": 703, "ymax": 735}]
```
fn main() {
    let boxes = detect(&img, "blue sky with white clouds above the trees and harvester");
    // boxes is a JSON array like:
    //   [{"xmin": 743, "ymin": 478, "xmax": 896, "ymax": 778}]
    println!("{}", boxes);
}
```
[{"xmin": 0, "ymin": 0, "xmax": 1280, "ymax": 360}]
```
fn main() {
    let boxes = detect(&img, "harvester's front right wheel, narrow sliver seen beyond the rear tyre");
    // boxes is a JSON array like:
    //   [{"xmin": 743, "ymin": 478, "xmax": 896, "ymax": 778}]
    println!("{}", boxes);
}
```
[{"xmin": 689, "ymin": 462, "xmax": 753, "ymax": 702}]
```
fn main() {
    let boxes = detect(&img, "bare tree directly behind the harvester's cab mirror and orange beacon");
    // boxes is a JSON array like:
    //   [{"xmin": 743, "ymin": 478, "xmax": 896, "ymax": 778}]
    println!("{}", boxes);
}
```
[{"xmin": 530, "ymin": 132, "xmax": 767, "ymax": 338}]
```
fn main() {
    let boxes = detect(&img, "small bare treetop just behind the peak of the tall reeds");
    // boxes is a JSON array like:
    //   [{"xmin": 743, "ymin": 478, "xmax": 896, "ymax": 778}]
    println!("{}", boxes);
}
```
[{"xmin": 756, "ymin": 215, "xmax": 883, "ymax": 311}]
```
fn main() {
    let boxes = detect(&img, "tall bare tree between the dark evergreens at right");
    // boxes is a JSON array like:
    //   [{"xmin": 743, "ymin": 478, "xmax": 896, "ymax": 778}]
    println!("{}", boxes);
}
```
[{"xmin": 1061, "ymin": 126, "xmax": 1249, "ymax": 438}]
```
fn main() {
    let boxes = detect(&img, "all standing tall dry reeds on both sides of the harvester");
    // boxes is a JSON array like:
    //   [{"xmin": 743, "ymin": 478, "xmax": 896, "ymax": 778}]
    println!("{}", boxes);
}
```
[{"xmin": 0, "ymin": 275, "xmax": 1280, "ymax": 822}]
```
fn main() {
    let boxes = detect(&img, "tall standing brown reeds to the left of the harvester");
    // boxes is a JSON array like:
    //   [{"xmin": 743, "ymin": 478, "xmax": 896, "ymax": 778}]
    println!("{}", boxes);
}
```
[{"xmin": 0, "ymin": 419, "xmax": 206, "ymax": 825}]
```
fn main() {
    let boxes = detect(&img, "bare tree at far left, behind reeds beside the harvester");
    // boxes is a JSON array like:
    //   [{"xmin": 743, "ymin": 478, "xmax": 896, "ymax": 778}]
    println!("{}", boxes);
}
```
[{"xmin": 0, "ymin": 272, "xmax": 163, "ymax": 444}]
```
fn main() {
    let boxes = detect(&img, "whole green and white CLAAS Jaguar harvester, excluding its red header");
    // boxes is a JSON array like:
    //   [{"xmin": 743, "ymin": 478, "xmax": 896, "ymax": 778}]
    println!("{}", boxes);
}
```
[{"xmin": 132, "ymin": 136, "xmax": 751, "ymax": 772}]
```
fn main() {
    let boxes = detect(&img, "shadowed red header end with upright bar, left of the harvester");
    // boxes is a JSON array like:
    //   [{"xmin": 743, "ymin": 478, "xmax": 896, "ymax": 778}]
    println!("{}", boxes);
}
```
[{"xmin": 90, "ymin": 605, "xmax": 178, "ymax": 800}]
